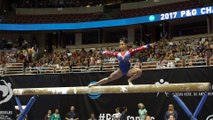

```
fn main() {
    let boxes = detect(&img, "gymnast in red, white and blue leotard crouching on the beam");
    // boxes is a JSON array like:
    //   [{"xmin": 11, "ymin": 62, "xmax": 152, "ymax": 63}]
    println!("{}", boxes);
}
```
[{"xmin": 88, "ymin": 37, "xmax": 155, "ymax": 87}]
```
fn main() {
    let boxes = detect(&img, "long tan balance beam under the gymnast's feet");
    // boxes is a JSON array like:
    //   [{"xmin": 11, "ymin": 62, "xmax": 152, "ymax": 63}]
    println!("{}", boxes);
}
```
[{"xmin": 13, "ymin": 82, "xmax": 211, "ymax": 95}]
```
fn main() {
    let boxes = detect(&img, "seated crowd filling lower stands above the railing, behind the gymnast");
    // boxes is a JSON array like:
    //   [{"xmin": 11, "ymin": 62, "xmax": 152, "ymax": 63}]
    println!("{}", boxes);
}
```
[{"xmin": 0, "ymin": 35, "xmax": 213, "ymax": 72}]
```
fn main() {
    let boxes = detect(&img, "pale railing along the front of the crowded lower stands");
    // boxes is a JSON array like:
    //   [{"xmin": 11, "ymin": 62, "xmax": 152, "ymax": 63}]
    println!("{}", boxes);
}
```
[{"xmin": 0, "ymin": 57, "xmax": 213, "ymax": 76}]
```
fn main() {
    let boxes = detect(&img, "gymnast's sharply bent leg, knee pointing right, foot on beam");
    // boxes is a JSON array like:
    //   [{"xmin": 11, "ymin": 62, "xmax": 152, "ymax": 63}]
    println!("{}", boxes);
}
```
[{"xmin": 127, "ymin": 68, "xmax": 142, "ymax": 85}]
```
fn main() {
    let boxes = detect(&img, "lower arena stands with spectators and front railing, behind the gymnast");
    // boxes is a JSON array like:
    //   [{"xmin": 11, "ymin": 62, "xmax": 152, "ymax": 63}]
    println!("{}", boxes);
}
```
[{"xmin": 0, "ymin": 34, "xmax": 213, "ymax": 75}]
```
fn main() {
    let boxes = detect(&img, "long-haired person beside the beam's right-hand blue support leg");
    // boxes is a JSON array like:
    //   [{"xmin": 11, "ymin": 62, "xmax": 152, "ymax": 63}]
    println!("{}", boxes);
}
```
[{"xmin": 165, "ymin": 104, "xmax": 178, "ymax": 120}]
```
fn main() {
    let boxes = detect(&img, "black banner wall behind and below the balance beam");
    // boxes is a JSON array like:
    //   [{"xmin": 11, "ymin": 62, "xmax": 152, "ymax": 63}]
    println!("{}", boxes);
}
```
[{"xmin": 0, "ymin": 67, "xmax": 213, "ymax": 120}]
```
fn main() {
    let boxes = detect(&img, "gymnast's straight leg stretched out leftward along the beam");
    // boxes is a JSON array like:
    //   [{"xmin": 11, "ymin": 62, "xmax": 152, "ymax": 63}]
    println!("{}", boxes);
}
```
[{"xmin": 89, "ymin": 69, "xmax": 123, "ymax": 87}]
